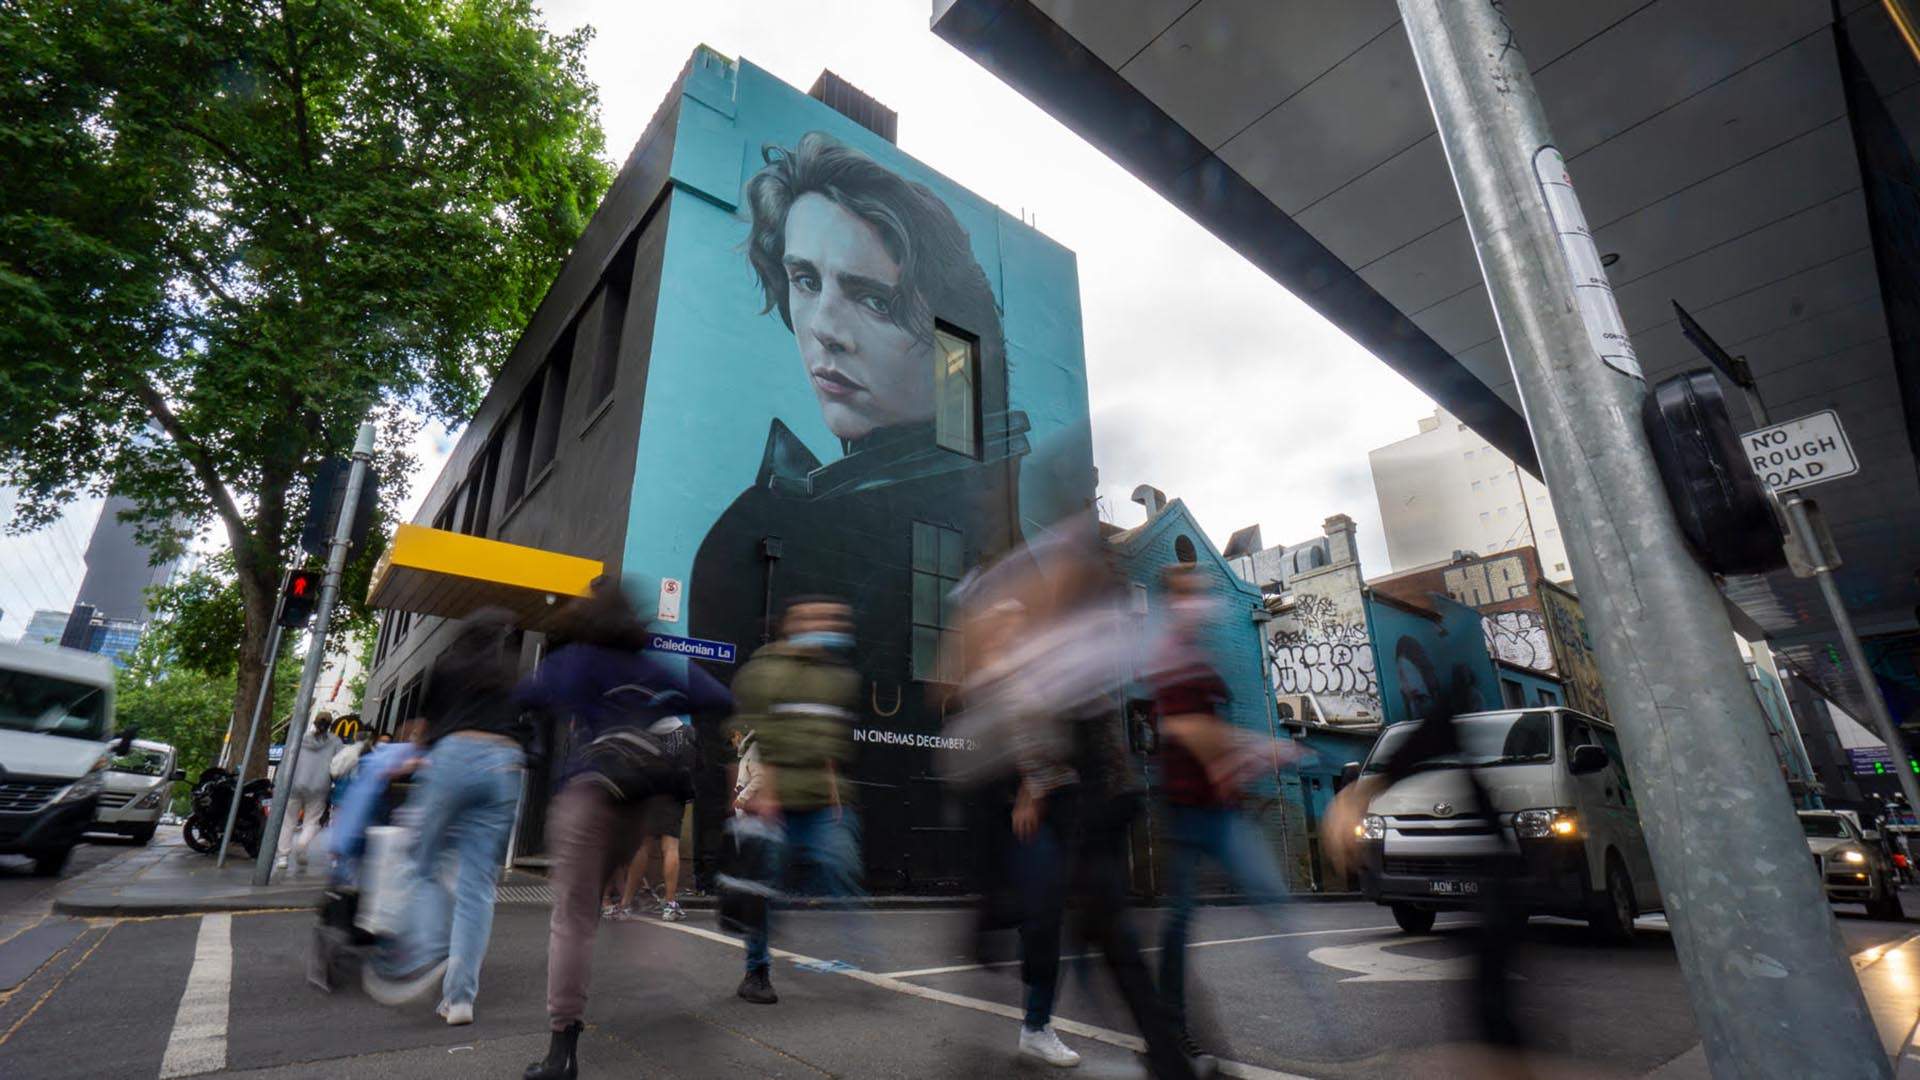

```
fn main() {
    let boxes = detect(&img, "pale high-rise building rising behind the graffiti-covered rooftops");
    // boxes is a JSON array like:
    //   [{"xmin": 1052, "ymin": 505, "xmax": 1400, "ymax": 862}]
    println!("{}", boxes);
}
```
[{"xmin": 1367, "ymin": 409, "xmax": 1572, "ymax": 582}]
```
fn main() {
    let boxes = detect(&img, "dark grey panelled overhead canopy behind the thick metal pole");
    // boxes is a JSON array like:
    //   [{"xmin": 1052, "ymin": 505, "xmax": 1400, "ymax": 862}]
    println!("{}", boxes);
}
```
[{"xmin": 933, "ymin": 0, "xmax": 1920, "ymax": 722}]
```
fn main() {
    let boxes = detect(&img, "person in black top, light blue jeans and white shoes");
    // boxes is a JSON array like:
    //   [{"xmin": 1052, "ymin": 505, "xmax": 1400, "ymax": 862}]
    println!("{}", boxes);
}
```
[{"xmin": 363, "ymin": 611, "xmax": 532, "ymax": 1024}]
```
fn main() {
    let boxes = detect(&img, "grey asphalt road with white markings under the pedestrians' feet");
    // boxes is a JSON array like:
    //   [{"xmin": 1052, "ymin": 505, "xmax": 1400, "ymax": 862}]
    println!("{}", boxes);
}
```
[{"xmin": 0, "ymin": 864, "xmax": 1920, "ymax": 1080}]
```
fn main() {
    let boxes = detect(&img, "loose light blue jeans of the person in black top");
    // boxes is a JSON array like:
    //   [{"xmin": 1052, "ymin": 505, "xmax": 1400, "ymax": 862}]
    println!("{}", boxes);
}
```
[{"xmin": 399, "ymin": 734, "xmax": 524, "ymax": 1005}]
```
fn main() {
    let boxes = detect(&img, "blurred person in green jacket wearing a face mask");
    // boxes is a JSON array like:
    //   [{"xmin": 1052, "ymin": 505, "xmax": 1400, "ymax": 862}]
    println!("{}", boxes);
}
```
[{"xmin": 730, "ymin": 596, "xmax": 860, "ymax": 1005}]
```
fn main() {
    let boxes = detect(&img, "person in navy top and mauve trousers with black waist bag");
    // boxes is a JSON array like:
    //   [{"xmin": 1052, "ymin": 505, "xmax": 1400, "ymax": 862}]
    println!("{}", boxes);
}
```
[{"xmin": 516, "ymin": 577, "xmax": 733, "ymax": 1080}]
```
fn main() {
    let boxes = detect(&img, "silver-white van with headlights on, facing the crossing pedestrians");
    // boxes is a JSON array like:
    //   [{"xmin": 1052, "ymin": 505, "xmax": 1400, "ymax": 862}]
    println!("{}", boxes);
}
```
[{"xmin": 1359, "ymin": 709, "xmax": 1661, "ymax": 944}]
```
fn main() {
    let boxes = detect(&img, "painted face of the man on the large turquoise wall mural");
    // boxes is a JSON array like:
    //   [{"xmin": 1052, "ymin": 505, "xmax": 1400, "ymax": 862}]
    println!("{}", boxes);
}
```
[{"xmin": 785, "ymin": 194, "xmax": 933, "ymax": 438}]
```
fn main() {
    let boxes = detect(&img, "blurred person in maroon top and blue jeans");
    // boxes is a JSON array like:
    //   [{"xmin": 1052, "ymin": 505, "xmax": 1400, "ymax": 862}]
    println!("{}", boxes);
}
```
[{"xmin": 1150, "ymin": 563, "xmax": 1298, "ymax": 1059}]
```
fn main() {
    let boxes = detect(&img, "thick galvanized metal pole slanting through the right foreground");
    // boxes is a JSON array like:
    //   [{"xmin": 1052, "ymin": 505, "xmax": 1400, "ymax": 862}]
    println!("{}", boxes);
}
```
[{"xmin": 1398, "ymin": 0, "xmax": 1891, "ymax": 1080}]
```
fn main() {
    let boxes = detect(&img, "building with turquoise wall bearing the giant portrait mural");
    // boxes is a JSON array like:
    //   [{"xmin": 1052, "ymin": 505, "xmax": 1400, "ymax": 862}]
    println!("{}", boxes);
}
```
[{"xmin": 367, "ymin": 48, "xmax": 1094, "ymax": 892}]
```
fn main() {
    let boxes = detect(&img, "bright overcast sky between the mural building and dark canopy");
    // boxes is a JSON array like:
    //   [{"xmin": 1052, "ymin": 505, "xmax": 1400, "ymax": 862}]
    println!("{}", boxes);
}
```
[{"xmin": 409, "ymin": 0, "xmax": 1432, "ymax": 575}]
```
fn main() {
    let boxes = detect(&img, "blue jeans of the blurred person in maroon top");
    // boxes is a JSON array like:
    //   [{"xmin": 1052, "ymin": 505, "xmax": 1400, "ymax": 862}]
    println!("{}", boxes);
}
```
[{"xmin": 1160, "ymin": 807, "xmax": 1286, "ymax": 1026}]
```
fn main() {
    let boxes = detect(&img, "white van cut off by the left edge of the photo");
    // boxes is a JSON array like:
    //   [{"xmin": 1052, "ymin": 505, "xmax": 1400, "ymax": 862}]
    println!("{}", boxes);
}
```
[{"xmin": 0, "ymin": 642, "xmax": 132, "ymax": 874}]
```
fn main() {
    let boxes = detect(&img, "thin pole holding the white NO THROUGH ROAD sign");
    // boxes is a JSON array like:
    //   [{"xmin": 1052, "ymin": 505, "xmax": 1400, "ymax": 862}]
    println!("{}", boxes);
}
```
[{"xmin": 1674, "ymin": 302, "xmax": 1920, "ymax": 813}]
